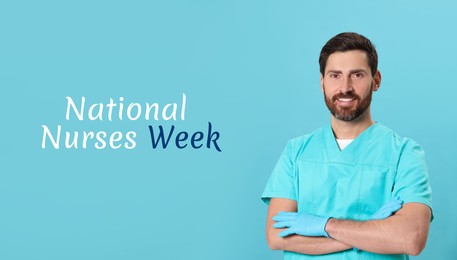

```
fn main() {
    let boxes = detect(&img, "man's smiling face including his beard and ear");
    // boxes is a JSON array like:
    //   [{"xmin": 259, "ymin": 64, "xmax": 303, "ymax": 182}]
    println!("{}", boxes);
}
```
[{"xmin": 321, "ymin": 50, "xmax": 381, "ymax": 121}]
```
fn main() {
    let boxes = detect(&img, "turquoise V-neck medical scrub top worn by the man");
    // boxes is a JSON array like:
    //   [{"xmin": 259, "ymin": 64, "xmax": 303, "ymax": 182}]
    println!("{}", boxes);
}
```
[{"xmin": 262, "ymin": 123, "xmax": 432, "ymax": 260}]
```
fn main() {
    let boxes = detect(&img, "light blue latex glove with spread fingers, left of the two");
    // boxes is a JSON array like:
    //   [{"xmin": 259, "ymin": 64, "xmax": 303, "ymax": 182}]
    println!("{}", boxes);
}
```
[{"xmin": 273, "ymin": 212, "xmax": 330, "ymax": 237}]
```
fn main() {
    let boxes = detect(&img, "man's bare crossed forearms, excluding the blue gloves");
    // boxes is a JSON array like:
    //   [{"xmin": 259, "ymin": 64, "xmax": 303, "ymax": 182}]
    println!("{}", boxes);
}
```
[{"xmin": 267, "ymin": 198, "xmax": 431, "ymax": 255}]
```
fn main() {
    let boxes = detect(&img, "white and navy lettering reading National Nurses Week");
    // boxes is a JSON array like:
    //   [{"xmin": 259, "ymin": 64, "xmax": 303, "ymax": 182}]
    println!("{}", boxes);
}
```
[{"xmin": 41, "ymin": 93, "xmax": 222, "ymax": 152}]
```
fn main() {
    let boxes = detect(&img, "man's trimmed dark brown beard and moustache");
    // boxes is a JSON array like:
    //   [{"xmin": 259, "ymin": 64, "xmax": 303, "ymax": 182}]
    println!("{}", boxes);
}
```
[{"xmin": 324, "ymin": 86, "xmax": 373, "ymax": 121}]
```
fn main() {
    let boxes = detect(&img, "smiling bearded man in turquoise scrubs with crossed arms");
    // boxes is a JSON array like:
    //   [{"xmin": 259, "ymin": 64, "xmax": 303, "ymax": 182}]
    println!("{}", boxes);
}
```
[{"xmin": 262, "ymin": 33, "xmax": 433, "ymax": 259}]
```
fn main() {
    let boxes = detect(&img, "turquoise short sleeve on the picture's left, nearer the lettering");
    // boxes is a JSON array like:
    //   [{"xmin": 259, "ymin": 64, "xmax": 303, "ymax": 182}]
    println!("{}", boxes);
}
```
[{"xmin": 262, "ymin": 141, "xmax": 297, "ymax": 205}]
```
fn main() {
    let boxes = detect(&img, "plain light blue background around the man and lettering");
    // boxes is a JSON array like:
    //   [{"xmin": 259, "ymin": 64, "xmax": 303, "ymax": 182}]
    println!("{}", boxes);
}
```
[{"xmin": 0, "ymin": 0, "xmax": 457, "ymax": 260}]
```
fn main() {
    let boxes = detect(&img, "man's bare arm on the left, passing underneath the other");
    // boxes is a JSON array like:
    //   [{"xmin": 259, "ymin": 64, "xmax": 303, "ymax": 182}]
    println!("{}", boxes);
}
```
[{"xmin": 267, "ymin": 198, "xmax": 352, "ymax": 255}]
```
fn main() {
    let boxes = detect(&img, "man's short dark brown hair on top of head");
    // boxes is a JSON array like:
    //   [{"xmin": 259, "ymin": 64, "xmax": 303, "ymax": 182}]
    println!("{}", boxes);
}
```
[{"xmin": 319, "ymin": 32, "xmax": 378, "ymax": 76}]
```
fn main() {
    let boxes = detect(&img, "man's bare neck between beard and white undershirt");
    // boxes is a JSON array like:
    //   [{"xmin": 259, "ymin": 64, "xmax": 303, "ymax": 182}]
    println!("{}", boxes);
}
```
[{"xmin": 331, "ymin": 109, "xmax": 375, "ymax": 139}]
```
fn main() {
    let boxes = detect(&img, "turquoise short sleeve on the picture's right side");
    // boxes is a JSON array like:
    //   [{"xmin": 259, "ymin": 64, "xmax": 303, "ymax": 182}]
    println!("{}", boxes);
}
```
[{"xmin": 393, "ymin": 140, "xmax": 433, "ymax": 219}]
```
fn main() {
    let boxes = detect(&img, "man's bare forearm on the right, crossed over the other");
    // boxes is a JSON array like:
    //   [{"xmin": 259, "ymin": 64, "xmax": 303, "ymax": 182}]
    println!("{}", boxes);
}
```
[{"xmin": 325, "ymin": 203, "xmax": 431, "ymax": 255}]
